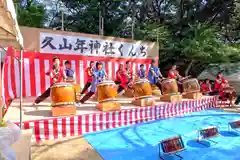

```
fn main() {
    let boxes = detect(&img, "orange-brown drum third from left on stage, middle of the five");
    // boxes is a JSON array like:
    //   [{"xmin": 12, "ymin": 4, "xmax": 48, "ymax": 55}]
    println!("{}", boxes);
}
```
[{"xmin": 133, "ymin": 79, "xmax": 152, "ymax": 97}]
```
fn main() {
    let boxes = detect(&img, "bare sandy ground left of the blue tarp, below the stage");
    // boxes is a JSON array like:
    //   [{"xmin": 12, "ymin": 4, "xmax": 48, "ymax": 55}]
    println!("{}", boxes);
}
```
[{"xmin": 31, "ymin": 137, "xmax": 102, "ymax": 160}]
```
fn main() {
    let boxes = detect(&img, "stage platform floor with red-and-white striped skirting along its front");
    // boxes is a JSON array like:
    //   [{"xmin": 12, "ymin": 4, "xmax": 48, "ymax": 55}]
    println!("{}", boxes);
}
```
[{"xmin": 5, "ymin": 96, "xmax": 218, "ymax": 141}]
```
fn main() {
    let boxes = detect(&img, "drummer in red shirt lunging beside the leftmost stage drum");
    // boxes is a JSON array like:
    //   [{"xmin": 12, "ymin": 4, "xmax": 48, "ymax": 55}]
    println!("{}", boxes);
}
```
[{"xmin": 34, "ymin": 56, "xmax": 67, "ymax": 105}]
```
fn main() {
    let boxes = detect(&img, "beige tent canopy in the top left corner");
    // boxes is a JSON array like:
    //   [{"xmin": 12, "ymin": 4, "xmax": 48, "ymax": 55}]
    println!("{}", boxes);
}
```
[{"xmin": 0, "ymin": 0, "xmax": 23, "ymax": 120}]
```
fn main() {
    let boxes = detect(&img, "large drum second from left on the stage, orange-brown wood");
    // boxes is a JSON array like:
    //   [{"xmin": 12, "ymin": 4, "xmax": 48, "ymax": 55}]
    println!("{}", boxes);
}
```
[{"xmin": 97, "ymin": 80, "xmax": 118, "ymax": 102}]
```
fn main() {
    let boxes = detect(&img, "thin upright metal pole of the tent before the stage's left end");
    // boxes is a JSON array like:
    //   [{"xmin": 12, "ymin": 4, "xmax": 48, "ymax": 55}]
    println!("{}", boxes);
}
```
[{"xmin": 19, "ymin": 49, "xmax": 23, "ymax": 129}]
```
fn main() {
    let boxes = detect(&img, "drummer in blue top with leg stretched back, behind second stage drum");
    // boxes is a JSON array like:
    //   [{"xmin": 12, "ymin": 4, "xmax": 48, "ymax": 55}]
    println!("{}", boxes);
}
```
[{"xmin": 80, "ymin": 62, "xmax": 107, "ymax": 104}]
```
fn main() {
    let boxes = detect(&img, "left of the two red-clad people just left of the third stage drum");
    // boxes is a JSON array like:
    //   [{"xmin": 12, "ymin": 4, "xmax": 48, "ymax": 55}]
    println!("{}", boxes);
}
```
[{"xmin": 115, "ymin": 64, "xmax": 128, "ymax": 93}]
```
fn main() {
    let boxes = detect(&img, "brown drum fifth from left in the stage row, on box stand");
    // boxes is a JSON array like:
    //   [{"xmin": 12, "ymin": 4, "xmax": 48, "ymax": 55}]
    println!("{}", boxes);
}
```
[{"xmin": 182, "ymin": 78, "xmax": 200, "ymax": 93}]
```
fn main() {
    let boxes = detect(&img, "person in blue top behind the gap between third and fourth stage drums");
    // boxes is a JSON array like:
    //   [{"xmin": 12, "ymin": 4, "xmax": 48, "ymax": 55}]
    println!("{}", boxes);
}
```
[{"xmin": 148, "ymin": 59, "xmax": 163, "ymax": 90}]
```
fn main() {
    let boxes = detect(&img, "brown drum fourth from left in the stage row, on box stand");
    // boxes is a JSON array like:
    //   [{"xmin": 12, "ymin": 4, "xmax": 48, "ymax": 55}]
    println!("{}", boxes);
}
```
[{"xmin": 161, "ymin": 79, "xmax": 178, "ymax": 94}]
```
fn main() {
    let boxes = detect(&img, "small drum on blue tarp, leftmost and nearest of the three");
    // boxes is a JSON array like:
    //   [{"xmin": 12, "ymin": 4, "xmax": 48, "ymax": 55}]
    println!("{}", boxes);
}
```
[{"xmin": 161, "ymin": 136, "xmax": 184, "ymax": 154}]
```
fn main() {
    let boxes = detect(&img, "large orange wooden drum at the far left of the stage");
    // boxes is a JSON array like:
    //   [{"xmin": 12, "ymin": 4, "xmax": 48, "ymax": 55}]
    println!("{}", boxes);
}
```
[{"xmin": 51, "ymin": 82, "xmax": 75, "ymax": 107}]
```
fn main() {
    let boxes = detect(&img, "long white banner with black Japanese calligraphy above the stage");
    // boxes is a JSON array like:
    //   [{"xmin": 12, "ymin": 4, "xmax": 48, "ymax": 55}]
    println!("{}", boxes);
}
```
[{"xmin": 40, "ymin": 32, "xmax": 150, "ymax": 58}]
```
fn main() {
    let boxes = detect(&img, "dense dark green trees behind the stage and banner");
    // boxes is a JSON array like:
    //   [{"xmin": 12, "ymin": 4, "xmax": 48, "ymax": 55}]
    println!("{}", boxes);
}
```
[{"xmin": 15, "ymin": 0, "xmax": 240, "ymax": 75}]
